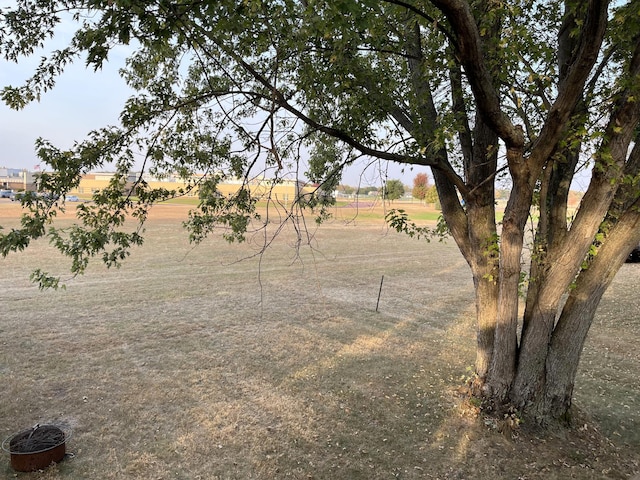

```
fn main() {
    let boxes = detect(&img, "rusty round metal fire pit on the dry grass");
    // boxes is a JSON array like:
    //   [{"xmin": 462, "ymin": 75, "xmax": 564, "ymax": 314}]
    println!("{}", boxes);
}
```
[{"xmin": 2, "ymin": 425, "xmax": 67, "ymax": 472}]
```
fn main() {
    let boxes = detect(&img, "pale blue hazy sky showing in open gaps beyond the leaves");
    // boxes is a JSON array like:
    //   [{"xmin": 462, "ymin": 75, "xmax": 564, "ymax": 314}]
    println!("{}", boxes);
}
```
[{"xmin": 0, "ymin": 24, "xmax": 429, "ymax": 187}]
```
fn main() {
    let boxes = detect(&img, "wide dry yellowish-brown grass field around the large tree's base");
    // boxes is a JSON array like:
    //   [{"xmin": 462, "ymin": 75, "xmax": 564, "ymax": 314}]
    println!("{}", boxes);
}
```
[{"xmin": 0, "ymin": 203, "xmax": 640, "ymax": 480}]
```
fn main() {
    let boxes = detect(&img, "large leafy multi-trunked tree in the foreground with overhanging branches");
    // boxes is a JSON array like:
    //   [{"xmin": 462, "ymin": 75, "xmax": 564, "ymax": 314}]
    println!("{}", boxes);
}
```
[{"xmin": 0, "ymin": 0, "xmax": 640, "ymax": 423}]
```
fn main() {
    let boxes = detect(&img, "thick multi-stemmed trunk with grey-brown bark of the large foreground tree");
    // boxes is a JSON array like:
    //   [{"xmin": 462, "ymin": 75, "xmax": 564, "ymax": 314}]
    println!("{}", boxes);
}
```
[{"xmin": 424, "ymin": 0, "xmax": 637, "ymax": 423}]
